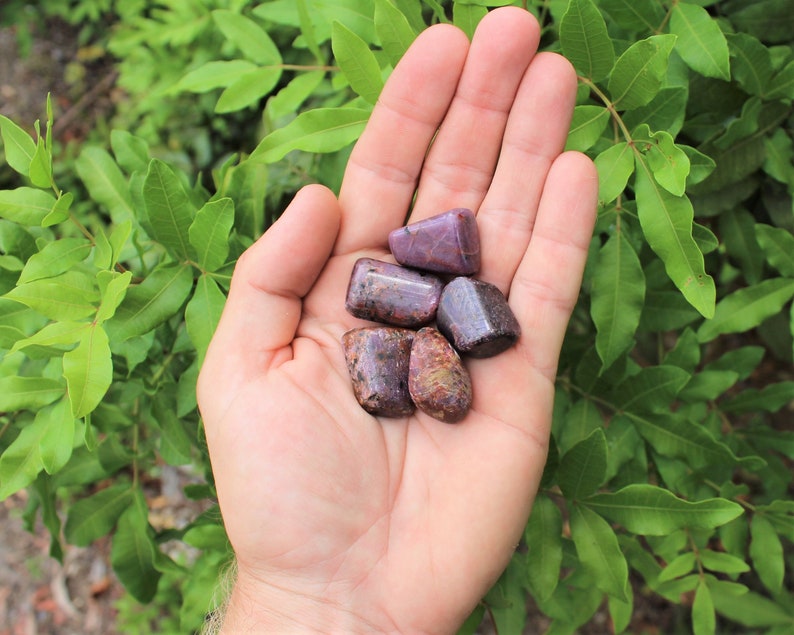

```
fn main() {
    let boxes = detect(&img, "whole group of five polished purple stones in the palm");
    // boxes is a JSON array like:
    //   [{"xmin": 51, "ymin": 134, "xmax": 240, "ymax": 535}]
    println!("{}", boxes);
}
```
[{"xmin": 342, "ymin": 208, "xmax": 521, "ymax": 423}]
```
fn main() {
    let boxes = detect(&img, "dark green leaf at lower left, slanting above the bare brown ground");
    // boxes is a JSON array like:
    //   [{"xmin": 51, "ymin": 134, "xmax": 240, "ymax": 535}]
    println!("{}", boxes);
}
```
[{"xmin": 63, "ymin": 483, "xmax": 134, "ymax": 547}]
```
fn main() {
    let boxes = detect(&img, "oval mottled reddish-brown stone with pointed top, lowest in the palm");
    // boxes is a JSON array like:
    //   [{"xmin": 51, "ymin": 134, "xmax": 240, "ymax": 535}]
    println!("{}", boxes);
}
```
[{"xmin": 408, "ymin": 327, "xmax": 472, "ymax": 423}]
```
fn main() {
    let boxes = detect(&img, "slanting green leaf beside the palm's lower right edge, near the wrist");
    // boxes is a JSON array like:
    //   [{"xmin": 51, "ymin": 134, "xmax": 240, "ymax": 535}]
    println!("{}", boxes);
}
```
[{"xmin": 571, "ymin": 505, "xmax": 629, "ymax": 601}]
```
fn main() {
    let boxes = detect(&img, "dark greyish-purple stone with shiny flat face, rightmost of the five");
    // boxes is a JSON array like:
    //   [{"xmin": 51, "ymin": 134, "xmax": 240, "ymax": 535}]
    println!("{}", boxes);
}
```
[{"xmin": 436, "ymin": 277, "xmax": 521, "ymax": 357}]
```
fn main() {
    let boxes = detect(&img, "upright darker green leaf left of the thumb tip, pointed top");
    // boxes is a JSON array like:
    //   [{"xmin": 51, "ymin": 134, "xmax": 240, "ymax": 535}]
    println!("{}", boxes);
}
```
[{"xmin": 143, "ymin": 159, "xmax": 196, "ymax": 260}]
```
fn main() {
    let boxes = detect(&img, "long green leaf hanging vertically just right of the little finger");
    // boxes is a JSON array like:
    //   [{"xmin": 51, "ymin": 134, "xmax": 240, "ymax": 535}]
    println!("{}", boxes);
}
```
[{"xmin": 590, "ymin": 232, "xmax": 645, "ymax": 368}]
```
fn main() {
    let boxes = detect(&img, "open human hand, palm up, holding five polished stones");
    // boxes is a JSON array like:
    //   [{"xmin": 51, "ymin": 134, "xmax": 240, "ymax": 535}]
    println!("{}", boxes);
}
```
[{"xmin": 198, "ymin": 7, "xmax": 597, "ymax": 633}]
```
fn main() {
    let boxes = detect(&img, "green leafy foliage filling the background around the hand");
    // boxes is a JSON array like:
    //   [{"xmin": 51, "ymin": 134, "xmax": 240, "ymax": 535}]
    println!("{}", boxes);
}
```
[{"xmin": 0, "ymin": 0, "xmax": 794, "ymax": 635}]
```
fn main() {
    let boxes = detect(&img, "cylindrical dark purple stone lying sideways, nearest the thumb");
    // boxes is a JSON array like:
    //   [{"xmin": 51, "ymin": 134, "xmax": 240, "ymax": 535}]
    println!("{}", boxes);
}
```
[{"xmin": 345, "ymin": 258, "xmax": 444, "ymax": 327}]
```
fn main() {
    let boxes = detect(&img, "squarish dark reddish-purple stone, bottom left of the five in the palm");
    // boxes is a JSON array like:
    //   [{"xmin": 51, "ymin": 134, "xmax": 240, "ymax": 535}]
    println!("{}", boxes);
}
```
[{"xmin": 342, "ymin": 326, "xmax": 414, "ymax": 417}]
